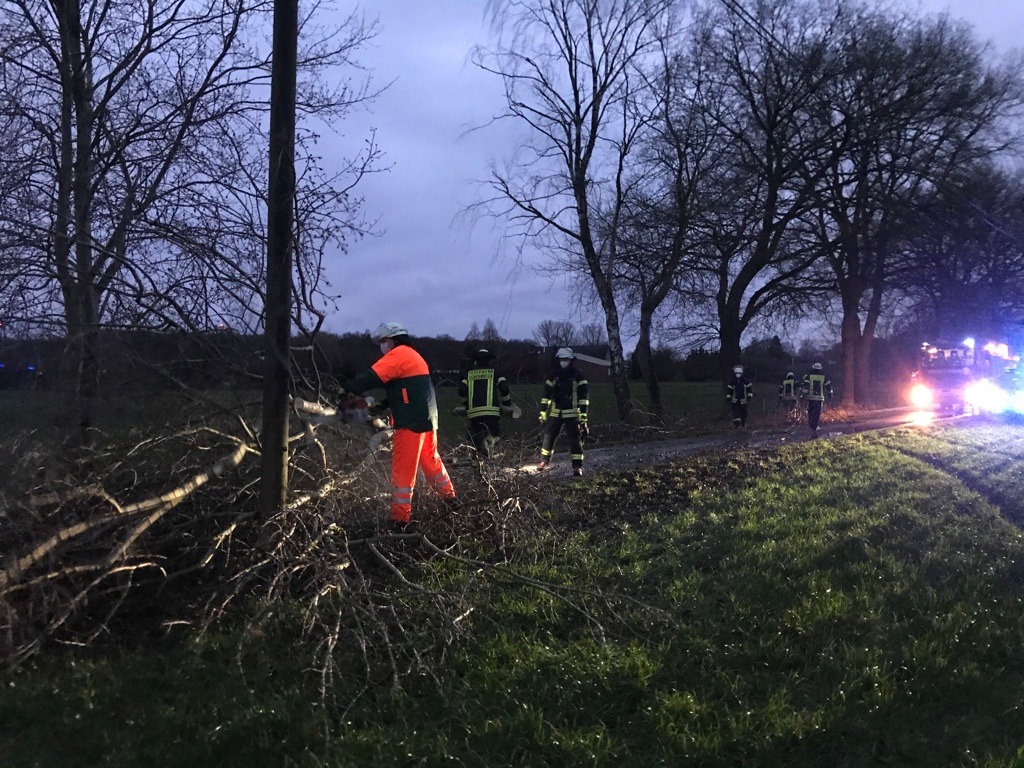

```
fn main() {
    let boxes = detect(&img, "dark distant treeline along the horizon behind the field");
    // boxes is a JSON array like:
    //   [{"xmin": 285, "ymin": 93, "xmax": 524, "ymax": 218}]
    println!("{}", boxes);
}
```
[{"xmin": 0, "ymin": 331, "xmax": 915, "ymax": 393}]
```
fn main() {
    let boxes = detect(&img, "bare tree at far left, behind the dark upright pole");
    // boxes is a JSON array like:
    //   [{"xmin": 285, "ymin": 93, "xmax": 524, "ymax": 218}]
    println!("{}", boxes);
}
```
[{"xmin": 0, "ymin": 0, "xmax": 373, "ymax": 438}]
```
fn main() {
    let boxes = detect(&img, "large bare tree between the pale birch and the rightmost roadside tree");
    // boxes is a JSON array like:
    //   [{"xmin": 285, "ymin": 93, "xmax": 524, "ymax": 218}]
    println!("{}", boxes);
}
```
[{"xmin": 688, "ymin": 0, "xmax": 845, "ymax": 377}]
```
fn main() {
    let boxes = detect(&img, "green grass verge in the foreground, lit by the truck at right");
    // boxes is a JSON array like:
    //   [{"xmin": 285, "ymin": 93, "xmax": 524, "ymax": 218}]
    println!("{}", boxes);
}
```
[{"xmin": 0, "ymin": 426, "xmax": 1024, "ymax": 768}]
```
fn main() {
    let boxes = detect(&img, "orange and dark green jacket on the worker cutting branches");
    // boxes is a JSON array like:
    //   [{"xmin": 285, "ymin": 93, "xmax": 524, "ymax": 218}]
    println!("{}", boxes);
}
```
[{"xmin": 345, "ymin": 344, "xmax": 437, "ymax": 432}]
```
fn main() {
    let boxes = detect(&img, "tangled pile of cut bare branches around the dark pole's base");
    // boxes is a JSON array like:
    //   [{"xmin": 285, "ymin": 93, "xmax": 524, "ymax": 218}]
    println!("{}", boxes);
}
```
[{"xmin": 0, "ymin": 423, "xmax": 550, "ymax": 691}]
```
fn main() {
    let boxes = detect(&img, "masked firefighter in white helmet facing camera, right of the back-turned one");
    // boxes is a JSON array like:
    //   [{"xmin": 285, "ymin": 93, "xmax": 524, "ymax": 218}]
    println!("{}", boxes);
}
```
[{"xmin": 537, "ymin": 347, "xmax": 590, "ymax": 477}]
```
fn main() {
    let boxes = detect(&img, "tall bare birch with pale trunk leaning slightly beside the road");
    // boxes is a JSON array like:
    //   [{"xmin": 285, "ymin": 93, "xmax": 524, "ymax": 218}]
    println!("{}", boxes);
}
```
[{"xmin": 474, "ymin": 0, "xmax": 675, "ymax": 419}]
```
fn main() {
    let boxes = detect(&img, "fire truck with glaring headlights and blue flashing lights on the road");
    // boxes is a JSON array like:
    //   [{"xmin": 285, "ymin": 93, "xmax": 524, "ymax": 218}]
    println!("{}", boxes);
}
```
[{"xmin": 909, "ymin": 339, "xmax": 1013, "ymax": 414}]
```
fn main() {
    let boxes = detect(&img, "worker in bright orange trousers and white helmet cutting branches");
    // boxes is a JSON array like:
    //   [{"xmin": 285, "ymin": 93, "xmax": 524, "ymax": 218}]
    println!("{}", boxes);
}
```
[{"xmin": 345, "ymin": 323, "xmax": 455, "ymax": 526}]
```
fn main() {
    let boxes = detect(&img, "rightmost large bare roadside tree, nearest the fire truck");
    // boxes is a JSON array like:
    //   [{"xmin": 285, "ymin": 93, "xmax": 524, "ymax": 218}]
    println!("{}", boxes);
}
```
[{"xmin": 813, "ymin": 13, "xmax": 1021, "ymax": 406}]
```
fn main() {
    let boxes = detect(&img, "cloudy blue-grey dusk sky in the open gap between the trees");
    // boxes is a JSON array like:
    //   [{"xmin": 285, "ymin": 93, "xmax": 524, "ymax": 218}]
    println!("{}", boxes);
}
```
[{"xmin": 327, "ymin": 0, "xmax": 1024, "ymax": 347}]
